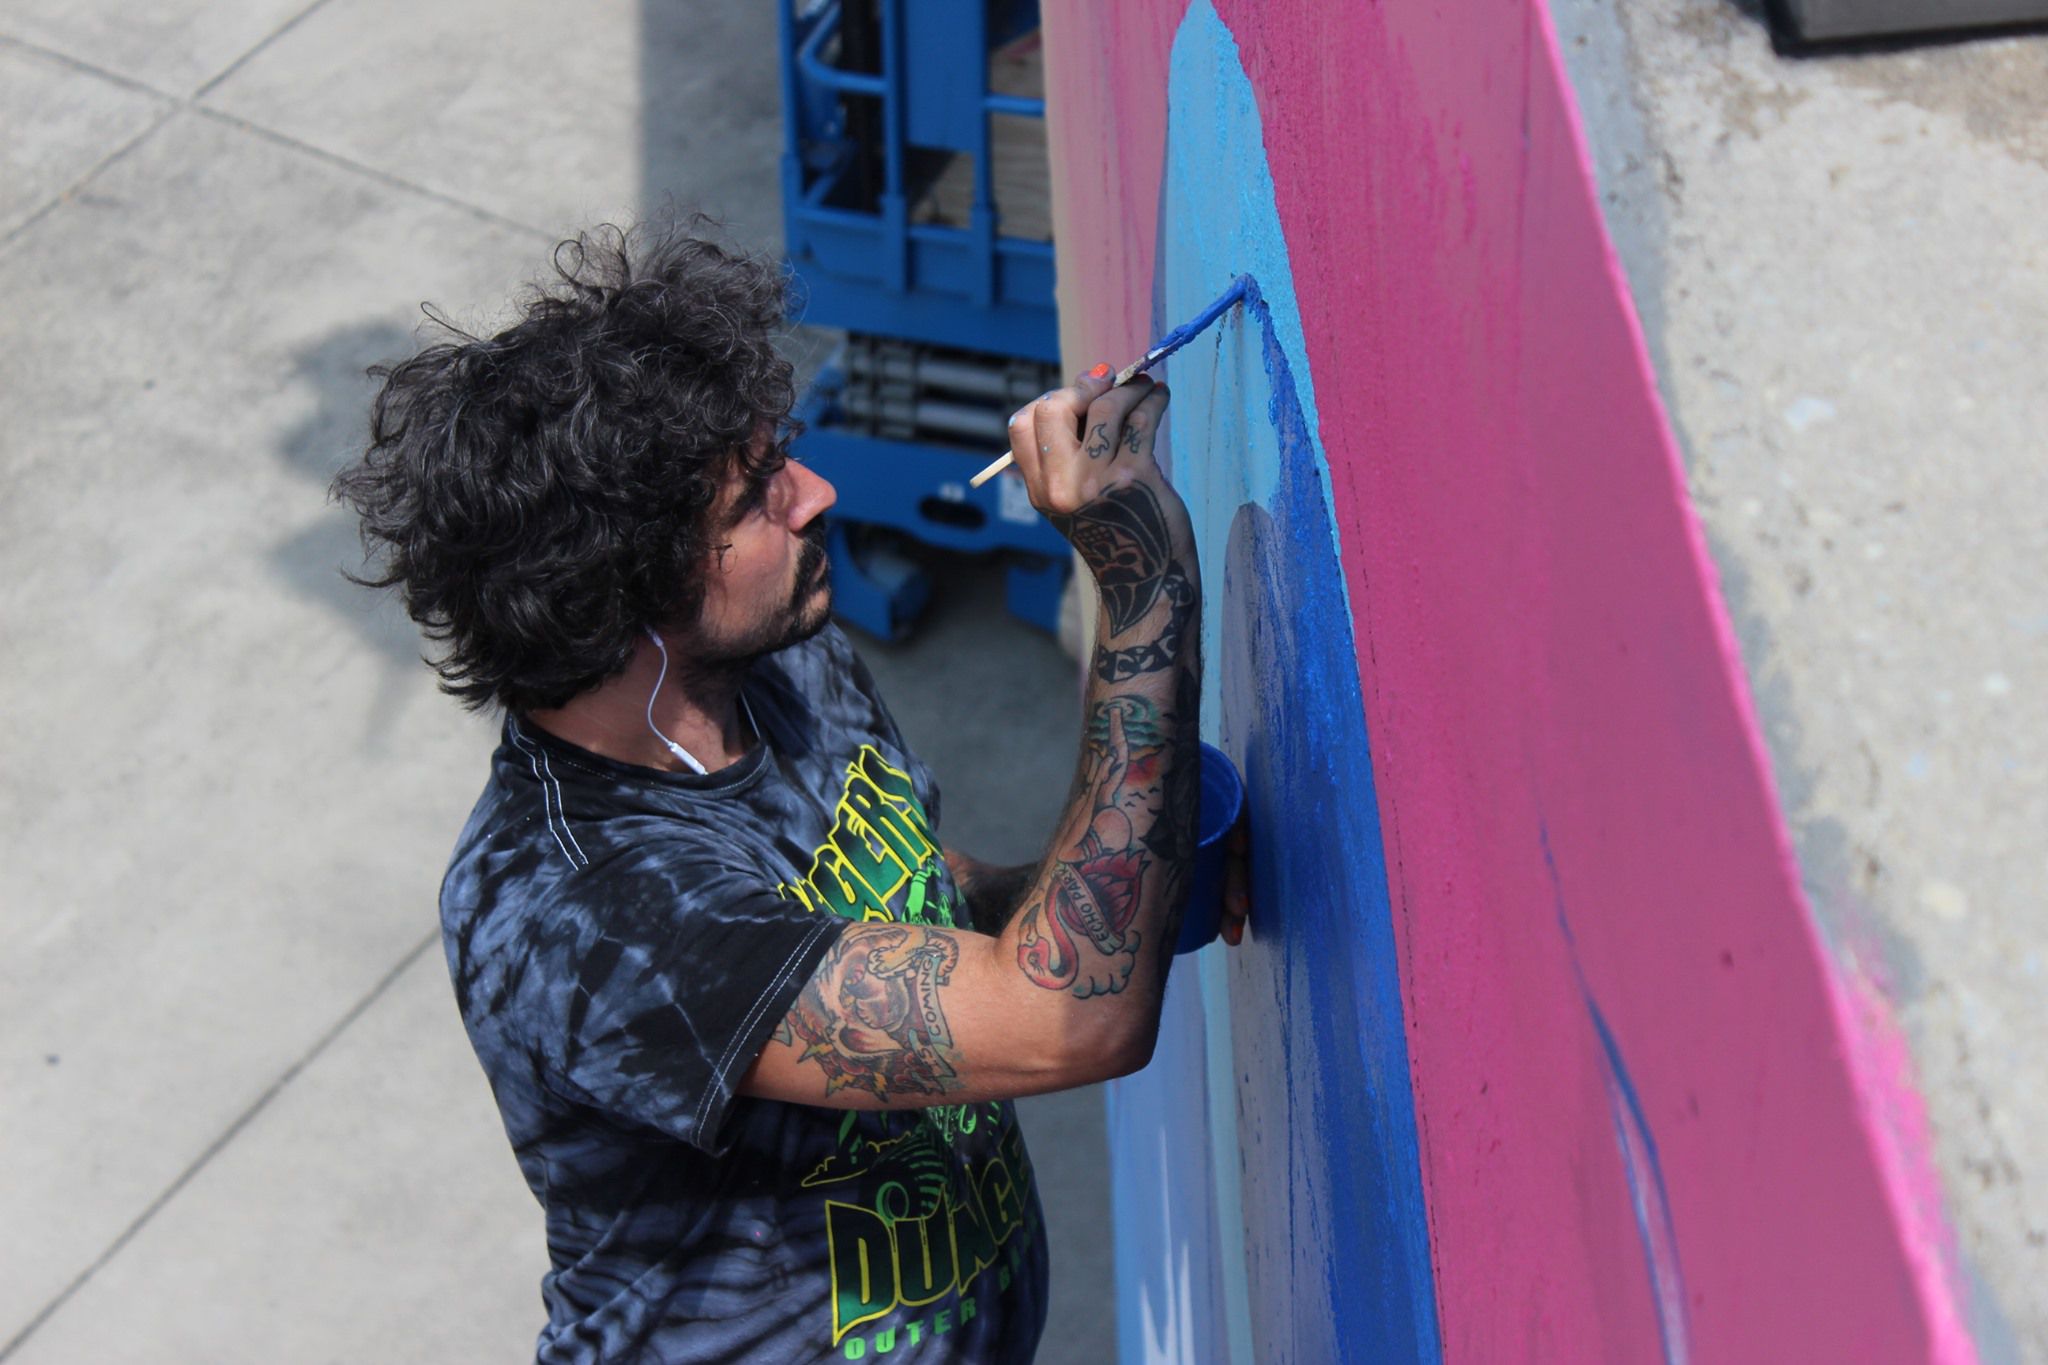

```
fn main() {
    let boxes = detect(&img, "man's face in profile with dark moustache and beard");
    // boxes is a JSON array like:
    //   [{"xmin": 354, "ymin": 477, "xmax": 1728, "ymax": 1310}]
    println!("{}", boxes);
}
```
[{"xmin": 690, "ymin": 436, "xmax": 838, "ymax": 665}]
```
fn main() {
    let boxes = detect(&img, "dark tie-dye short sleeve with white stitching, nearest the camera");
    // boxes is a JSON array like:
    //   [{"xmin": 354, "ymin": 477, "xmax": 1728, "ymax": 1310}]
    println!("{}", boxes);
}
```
[{"xmin": 549, "ymin": 845, "xmax": 846, "ymax": 1156}]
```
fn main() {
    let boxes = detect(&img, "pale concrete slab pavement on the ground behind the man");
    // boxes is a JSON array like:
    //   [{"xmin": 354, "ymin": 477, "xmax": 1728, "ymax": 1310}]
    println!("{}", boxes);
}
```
[{"xmin": 0, "ymin": 0, "xmax": 1112, "ymax": 1365}]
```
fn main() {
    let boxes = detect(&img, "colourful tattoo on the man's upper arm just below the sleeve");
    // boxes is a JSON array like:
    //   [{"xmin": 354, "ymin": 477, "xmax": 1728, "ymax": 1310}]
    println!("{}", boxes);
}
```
[{"xmin": 776, "ymin": 925, "xmax": 961, "ymax": 1099}]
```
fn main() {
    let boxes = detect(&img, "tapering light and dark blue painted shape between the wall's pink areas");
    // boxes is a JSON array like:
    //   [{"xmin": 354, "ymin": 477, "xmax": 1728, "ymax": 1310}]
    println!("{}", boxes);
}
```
[{"xmin": 1112, "ymin": 0, "xmax": 1442, "ymax": 1365}]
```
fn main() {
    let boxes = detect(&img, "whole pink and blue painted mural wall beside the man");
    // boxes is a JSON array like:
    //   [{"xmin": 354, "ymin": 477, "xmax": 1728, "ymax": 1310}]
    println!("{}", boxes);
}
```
[{"xmin": 1044, "ymin": 0, "xmax": 1974, "ymax": 1363}]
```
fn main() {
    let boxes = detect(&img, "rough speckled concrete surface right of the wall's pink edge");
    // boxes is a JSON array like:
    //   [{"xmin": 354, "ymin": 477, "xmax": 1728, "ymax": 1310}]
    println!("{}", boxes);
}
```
[{"xmin": 1550, "ymin": 0, "xmax": 2048, "ymax": 1361}]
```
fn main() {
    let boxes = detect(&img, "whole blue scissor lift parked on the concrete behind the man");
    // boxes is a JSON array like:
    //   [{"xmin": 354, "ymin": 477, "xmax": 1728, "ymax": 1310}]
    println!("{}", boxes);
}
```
[{"xmin": 780, "ymin": 0, "xmax": 1069, "ymax": 639}]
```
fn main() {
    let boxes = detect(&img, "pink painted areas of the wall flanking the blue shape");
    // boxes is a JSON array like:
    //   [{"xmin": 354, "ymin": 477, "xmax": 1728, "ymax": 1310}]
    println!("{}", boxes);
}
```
[{"xmin": 1044, "ymin": 0, "xmax": 1974, "ymax": 1363}]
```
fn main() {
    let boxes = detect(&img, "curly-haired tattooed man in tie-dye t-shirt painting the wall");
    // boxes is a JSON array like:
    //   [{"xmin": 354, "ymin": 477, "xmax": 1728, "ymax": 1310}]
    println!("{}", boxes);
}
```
[{"xmin": 336, "ymin": 222, "xmax": 1245, "ymax": 1361}]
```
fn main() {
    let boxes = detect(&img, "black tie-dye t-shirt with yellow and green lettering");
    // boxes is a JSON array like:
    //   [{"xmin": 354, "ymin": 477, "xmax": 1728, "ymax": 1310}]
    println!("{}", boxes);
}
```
[{"xmin": 442, "ymin": 628, "xmax": 1047, "ymax": 1365}]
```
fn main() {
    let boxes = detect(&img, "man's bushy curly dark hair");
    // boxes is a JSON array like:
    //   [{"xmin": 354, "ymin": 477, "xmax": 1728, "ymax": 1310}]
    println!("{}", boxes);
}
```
[{"xmin": 332, "ymin": 219, "xmax": 795, "ymax": 712}]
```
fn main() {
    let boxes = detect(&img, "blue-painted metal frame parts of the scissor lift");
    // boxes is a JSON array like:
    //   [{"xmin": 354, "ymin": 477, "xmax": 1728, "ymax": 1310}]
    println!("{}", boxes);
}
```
[{"xmin": 778, "ymin": 0, "xmax": 1069, "ymax": 639}]
